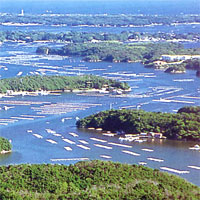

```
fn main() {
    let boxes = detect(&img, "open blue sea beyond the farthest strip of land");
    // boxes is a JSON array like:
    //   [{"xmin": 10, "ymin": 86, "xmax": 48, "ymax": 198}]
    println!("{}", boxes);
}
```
[{"xmin": 0, "ymin": 0, "xmax": 200, "ymax": 15}]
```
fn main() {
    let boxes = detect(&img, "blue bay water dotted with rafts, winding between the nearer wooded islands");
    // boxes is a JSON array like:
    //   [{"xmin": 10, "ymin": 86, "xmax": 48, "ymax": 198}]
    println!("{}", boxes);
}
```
[{"xmin": 0, "ymin": 39, "xmax": 200, "ymax": 185}]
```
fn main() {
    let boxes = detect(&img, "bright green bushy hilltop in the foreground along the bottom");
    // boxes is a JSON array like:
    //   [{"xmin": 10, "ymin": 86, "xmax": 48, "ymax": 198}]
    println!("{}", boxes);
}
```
[{"xmin": 0, "ymin": 160, "xmax": 200, "ymax": 200}]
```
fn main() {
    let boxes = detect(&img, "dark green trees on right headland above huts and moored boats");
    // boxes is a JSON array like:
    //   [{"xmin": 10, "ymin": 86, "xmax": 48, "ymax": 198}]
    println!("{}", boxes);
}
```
[{"xmin": 77, "ymin": 106, "xmax": 200, "ymax": 141}]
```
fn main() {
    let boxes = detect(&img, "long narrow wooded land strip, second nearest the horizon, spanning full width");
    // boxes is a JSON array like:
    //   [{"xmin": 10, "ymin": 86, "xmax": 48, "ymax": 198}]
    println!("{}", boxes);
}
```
[{"xmin": 0, "ymin": 31, "xmax": 200, "ymax": 43}]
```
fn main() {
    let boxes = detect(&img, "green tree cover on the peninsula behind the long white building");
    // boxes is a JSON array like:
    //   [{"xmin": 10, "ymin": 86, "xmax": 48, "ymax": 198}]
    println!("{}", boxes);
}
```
[{"xmin": 36, "ymin": 41, "xmax": 200, "ymax": 65}]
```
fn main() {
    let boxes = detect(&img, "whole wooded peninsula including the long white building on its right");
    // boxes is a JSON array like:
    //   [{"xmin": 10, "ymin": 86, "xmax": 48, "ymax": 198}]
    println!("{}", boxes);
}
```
[{"xmin": 36, "ymin": 41, "xmax": 200, "ymax": 75}]
